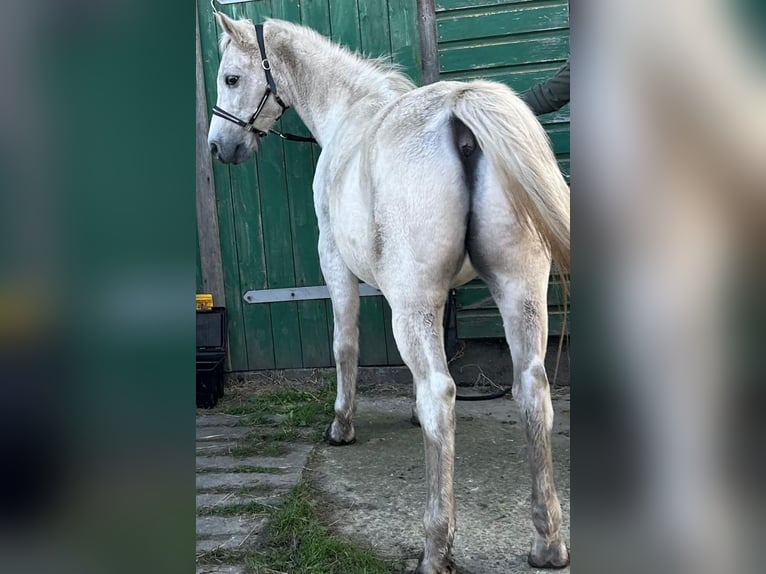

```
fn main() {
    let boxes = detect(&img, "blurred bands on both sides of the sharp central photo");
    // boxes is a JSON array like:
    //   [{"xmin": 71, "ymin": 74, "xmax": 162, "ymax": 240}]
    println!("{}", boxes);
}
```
[{"xmin": 0, "ymin": 0, "xmax": 766, "ymax": 573}]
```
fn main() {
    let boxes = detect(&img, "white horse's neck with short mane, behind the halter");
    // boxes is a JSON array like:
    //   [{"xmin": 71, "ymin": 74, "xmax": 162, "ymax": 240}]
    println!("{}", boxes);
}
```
[{"xmin": 265, "ymin": 21, "xmax": 406, "ymax": 146}]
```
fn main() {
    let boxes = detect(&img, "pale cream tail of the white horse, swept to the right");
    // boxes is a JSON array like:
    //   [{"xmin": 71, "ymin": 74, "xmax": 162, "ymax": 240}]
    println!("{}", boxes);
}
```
[{"xmin": 452, "ymin": 80, "xmax": 570, "ymax": 285}]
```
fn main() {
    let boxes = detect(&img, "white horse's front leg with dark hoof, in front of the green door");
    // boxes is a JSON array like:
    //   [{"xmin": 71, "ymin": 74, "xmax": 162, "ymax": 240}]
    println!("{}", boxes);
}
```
[{"xmin": 319, "ymin": 234, "xmax": 359, "ymax": 446}]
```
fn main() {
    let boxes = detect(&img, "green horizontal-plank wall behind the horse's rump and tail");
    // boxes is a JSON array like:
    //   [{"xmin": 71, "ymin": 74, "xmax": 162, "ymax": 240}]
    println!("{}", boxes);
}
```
[{"xmin": 436, "ymin": 0, "xmax": 569, "ymax": 339}]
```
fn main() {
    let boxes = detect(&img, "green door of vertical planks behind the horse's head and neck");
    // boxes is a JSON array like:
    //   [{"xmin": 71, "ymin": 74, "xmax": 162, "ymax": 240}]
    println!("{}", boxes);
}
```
[{"xmin": 197, "ymin": 0, "xmax": 420, "ymax": 371}]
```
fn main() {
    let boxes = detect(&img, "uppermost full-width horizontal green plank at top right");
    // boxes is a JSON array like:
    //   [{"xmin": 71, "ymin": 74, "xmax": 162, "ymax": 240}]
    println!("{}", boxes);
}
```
[{"xmin": 436, "ymin": 1, "xmax": 569, "ymax": 43}]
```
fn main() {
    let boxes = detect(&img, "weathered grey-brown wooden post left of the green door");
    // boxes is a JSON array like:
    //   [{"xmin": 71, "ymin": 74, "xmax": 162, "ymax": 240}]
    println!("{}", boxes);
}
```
[{"xmin": 196, "ymin": 10, "xmax": 226, "ymax": 306}]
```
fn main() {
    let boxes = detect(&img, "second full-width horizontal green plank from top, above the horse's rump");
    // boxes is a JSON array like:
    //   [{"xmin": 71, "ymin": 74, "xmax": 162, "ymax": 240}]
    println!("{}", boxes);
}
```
[{"xmin": 439, "ymin": 30, "xmax": 569, "ymax": 72}]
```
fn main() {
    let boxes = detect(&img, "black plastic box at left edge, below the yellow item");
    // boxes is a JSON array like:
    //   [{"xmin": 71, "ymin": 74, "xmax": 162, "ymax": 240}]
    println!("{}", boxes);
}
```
[{"xmin": 197, "ymin": 307, "xmax": 226, "ymax": 409}]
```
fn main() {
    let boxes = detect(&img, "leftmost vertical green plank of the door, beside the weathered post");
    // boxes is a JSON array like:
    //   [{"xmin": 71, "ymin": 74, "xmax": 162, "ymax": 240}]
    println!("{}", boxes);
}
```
[{"xmin": 198, "ymin": 4, "xmax": 248, "ymax": 371}]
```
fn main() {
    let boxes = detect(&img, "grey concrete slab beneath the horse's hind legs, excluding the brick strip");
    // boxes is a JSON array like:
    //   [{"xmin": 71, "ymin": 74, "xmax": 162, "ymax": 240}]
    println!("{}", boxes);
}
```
[{"xmin": 307, "ymin": 390, "xmax": 569, "ymax": 574}]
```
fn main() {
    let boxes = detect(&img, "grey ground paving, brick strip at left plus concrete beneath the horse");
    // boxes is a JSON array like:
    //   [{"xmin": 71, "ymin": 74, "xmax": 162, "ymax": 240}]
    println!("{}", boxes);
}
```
[{"xmin": 197, "ymin": 380, "xmax": 569, "ymax": 574}]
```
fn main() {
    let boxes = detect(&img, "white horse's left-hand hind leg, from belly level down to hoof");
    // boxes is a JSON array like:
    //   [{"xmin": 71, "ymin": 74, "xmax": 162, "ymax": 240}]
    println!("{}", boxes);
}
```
[{"xmin": 391, "ymin": 304, "xmax": 456, "ymax": 574}]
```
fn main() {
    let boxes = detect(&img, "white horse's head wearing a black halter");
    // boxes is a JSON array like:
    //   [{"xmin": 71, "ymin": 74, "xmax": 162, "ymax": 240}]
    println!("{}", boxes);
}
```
[{"xmin": 208, "ymin": 12, "xmax": 284, "ymax": 163}]
